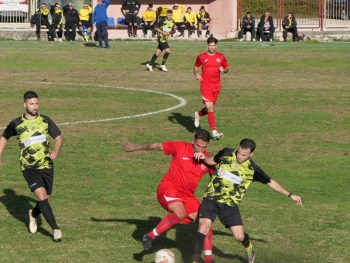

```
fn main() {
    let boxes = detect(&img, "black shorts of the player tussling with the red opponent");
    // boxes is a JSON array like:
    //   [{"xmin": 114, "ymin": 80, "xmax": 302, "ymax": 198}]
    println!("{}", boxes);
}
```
[{"xmin": 199, "ymin": 198, "xmax": 243, "ymax": 228}]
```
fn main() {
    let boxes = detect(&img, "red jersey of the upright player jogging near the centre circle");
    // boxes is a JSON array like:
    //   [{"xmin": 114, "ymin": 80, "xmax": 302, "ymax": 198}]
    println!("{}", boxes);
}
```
[{"xmin": 194, "ymin": 52, "xmax": 229, "ymax": 90}]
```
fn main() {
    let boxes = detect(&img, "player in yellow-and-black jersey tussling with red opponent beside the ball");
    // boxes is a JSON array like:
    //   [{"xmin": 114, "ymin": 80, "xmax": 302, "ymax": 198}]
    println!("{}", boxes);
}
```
[{"xmin": 193, "ymin": 139, "xmax": 302, "ymax": 263}]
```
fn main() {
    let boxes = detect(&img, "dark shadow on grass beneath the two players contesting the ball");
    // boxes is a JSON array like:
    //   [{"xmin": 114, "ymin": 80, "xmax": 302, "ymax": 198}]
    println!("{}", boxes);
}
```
[{"xmin": 91, "ymin": 217, "xmax": 245, "ymax": 262}]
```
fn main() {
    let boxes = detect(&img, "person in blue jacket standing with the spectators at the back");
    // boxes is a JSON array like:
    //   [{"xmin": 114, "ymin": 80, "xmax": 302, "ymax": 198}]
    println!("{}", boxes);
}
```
[{"xmin": 93, "ymin": 0, "xmax": 110, "ymax": 48}]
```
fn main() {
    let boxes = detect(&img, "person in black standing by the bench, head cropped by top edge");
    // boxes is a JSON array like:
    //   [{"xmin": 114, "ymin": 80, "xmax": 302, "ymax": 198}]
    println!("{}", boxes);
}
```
[{"xmin": 122, "ymin": 0, "xmax": 141, "ymax": 37}]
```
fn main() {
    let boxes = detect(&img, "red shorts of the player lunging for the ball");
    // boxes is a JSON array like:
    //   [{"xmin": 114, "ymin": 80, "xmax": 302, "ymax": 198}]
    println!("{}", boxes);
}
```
[{"xmin": 157, "ymin": 184, "xmax": 200, "ymax": 223}]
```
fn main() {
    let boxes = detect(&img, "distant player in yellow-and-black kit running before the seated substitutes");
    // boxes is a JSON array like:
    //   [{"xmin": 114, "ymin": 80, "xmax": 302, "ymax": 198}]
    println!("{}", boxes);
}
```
[{"xmin": 146, "ymin": 10, "xmax": 176, "ymax": 72}]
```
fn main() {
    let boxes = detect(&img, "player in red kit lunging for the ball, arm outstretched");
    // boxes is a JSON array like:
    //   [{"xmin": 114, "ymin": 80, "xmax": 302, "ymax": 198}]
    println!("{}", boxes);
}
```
[{"xmin": 123, "ymin": 129, "xmax": 213, "ymax": 263}]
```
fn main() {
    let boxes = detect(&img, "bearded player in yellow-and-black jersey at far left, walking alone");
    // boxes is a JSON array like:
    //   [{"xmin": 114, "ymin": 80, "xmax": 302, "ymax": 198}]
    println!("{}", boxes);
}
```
[{"xmin": 0, "ymin": 91, "xmax": 62, "ymax": 241}]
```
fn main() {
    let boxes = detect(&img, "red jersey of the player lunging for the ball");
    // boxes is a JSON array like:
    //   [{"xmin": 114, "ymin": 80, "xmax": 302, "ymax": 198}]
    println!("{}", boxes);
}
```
[{"xmin": 160, "ymin": 141, "xmax": 213, "ymax": 196}]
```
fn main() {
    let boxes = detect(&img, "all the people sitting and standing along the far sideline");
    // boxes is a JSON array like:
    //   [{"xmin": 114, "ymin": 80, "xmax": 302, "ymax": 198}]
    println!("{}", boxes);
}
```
[{"xmin": 31, "ymin": 0, "xmax": 302, "ymax": 42}]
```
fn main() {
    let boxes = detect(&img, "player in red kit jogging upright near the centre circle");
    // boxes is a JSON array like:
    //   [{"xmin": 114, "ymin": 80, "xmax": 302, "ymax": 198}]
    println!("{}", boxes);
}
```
[{"xmin": 193, "ymin": 35, "xmax": 229, "ymax": 140}]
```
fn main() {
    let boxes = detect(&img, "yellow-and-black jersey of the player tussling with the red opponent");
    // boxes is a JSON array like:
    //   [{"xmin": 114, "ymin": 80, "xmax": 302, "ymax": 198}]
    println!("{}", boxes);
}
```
[{"xmin": 204, "ymin": 148, "xmax": 271, "ymax": 206}]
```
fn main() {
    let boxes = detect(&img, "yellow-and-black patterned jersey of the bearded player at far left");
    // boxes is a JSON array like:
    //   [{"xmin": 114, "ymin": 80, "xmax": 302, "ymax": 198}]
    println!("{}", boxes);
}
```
[{"xmin": 2, "ymin": 114, "xmax": 61, "ymax": 171}]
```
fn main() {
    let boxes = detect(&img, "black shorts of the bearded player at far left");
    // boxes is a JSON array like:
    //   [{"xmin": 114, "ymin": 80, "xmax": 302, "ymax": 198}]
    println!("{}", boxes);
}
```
[{"xmin": 22, "ymin": 168, "xmax": 54, "ymax": 195}]
